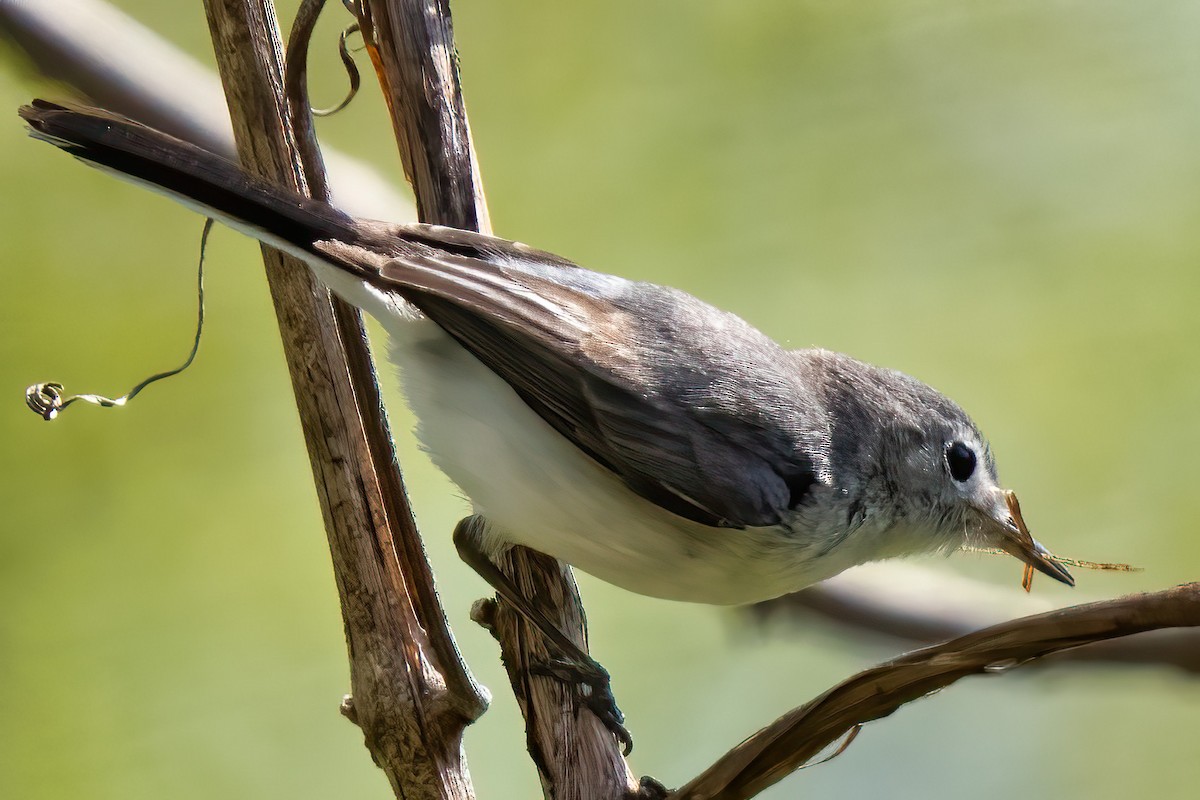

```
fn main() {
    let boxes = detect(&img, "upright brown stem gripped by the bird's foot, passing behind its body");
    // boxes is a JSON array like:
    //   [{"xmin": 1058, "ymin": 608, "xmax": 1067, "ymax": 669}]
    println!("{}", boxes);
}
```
[{"xmin": 359, "ymin": 0, "xmax": 636, "ymax": 800}]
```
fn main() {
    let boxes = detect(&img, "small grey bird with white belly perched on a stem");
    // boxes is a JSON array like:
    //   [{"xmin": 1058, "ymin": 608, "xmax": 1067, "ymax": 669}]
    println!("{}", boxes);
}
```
[{"xmin": 20, "ymin": 101, "xmax": 1074, "ymax": 745}]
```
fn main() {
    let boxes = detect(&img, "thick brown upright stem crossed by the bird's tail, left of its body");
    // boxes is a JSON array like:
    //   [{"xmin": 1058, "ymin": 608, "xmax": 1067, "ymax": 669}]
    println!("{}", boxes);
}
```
[{"xmin": 205, "ymin": 0, "xmax": 485, "ymax": 799}]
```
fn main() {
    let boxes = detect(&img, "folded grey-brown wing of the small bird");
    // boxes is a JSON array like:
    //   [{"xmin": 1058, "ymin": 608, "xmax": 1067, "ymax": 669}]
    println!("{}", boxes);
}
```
[{"xmin": 316, "ymin": 225, "xmax": 814, "ymax": 528}]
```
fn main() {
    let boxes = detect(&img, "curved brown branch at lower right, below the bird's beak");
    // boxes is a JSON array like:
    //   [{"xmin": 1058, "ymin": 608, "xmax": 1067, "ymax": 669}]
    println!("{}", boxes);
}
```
[{"xmin": 671, "ymin": 583, "xmax": 1200, "ymax": 800}]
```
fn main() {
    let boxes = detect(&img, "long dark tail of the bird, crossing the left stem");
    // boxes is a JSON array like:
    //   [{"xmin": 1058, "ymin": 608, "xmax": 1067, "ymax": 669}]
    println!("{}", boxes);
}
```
[{"xmin": 18, "ymin": 100, "xmax": 358, "ymax": 266}]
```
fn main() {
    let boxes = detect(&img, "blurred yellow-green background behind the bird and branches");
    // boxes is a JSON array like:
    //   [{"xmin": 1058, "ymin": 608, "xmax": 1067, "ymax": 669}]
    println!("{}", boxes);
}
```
[{"xmin": 0, "ymin": 0, "xmax": 1200, "ymax": 800}]
